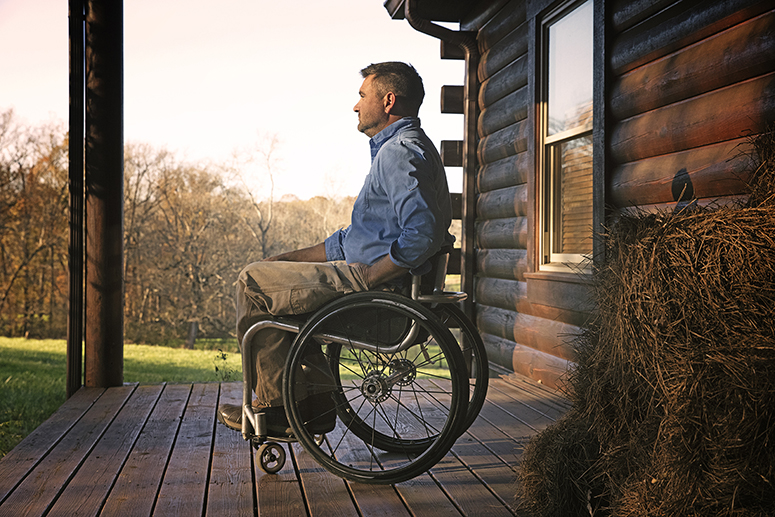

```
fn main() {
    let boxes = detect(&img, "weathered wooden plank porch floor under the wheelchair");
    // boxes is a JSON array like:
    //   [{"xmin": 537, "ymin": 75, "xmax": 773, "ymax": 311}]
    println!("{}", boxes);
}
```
[{"xmin": 0, "ymin": 377, "xmax": 568, "ymax": 517}]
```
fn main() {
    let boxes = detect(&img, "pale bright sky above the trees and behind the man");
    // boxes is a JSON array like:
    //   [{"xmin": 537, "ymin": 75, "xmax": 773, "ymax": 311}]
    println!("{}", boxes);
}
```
[{"xmin": 0, "ymin": 0, "xmax": 464, "ymax": 199}]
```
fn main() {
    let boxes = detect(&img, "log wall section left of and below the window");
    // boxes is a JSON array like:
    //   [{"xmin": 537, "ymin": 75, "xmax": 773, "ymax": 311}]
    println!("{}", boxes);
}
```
[{"xmin": 461, "ymin": 0, "xmax": 588, "ymax": 386}]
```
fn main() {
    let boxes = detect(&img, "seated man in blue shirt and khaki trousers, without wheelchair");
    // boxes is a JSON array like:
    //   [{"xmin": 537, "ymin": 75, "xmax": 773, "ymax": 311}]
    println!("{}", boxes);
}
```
[{"xmin": 217, "ymin": 62, "xmax": 454, "ymax": 437}]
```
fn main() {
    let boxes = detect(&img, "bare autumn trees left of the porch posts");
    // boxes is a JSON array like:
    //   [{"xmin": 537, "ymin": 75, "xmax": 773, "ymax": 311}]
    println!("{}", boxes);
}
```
[{"xmin": 0, "ymin": 110, "xmax": 67, "ymax": 335}]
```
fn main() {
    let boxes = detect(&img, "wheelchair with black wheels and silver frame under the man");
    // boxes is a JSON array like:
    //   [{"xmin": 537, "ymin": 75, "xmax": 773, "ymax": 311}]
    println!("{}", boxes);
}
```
[{"xmin": 242, "ymin": 252, "xmax": 488, "ymax": 483}]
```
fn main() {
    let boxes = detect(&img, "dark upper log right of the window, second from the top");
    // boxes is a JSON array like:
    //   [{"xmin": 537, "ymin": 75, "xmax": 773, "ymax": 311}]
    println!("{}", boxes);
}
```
[{"xmin": 610, "ymin": 0, "xmax": 772, "ymax": 75}]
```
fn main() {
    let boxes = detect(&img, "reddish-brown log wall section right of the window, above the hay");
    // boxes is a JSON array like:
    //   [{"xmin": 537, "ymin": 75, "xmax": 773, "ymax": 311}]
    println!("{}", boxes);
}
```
[{"xmin": 608, "ymin": 0, "xmax": 775, "ymax": 209}]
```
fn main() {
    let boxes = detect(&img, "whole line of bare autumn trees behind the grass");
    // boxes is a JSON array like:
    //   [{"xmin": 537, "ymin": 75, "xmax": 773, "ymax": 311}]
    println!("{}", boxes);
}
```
[{"xmin": 0, "ymin": 110, "xmax": 353, "ymax": 344}]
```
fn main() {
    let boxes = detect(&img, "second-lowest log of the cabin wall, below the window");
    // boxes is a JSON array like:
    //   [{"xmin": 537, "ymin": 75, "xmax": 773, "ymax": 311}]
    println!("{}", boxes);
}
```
[{"xmin": 476, "ymin": 304, "xmax": 581, "ymax": 361}]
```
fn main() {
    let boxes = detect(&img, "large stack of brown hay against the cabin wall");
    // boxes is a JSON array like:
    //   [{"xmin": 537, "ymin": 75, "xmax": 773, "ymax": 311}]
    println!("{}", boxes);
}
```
[{"xmin": 520, "ymin": 128, "xmax": 775, "ymax": 516}]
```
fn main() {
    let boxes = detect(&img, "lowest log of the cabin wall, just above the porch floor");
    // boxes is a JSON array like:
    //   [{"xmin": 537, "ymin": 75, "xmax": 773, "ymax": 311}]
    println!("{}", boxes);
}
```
[{"xmin": 482, "ymin": 334, "xmax": 573, "ymax": 389}]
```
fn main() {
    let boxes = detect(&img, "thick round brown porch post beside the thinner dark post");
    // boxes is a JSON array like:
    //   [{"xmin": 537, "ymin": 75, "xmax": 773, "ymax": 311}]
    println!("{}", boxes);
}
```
[{"xmin": 85, "ymin": 0, "xmax": 124, "ymax": 387}]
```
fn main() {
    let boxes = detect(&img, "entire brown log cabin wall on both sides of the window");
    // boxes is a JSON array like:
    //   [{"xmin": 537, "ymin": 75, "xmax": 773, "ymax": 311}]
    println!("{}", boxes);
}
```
[{"xmin": 454, "ymin": 0, "xmax": 775, "ymax": 386}]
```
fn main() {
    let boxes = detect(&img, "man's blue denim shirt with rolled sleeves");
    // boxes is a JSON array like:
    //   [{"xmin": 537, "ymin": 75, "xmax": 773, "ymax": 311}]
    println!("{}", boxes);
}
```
[{"xmin": 325, "ymin": 117, "xmax": 455, "ymax": 274}]
